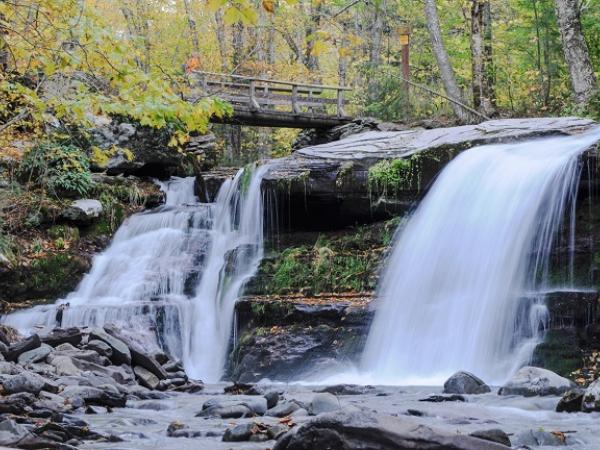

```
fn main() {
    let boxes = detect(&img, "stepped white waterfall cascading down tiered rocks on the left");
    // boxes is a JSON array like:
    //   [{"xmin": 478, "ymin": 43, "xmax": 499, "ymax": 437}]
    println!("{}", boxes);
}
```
[{"xmin": 2, "ymin": 165, "xmax": 269, "ymax": 381}]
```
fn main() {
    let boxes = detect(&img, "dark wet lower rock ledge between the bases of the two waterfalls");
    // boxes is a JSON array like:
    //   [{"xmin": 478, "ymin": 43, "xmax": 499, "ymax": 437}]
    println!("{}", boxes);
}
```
[{"xmin": 229, "ymin": 298, "xmax": 372, "ymax": 383}]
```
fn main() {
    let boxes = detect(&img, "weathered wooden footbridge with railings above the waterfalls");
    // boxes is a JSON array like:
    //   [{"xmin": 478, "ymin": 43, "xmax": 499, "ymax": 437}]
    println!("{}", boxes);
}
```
[{"xmin": 190, "ymin": 71, "xmax": 352, "ymax": 128}]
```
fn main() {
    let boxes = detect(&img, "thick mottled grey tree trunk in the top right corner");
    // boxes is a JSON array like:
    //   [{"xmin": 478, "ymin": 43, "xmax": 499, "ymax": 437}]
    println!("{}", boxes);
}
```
[{"xmin": 554, "ymin": 0, "xmax": 596, "ymax": 106}]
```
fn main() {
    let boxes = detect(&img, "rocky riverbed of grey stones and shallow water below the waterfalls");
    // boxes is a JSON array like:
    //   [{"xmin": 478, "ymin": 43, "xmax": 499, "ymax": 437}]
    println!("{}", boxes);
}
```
[{"xmin": 0, "ymin": 327, "xmax": 600, "ymax": 450}]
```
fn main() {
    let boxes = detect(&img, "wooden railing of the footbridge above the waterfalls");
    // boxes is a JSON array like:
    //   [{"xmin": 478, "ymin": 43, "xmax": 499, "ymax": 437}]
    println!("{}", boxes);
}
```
[{"xmin": 192, "ymin": 71, "xmax": 351, "ymax": 118}]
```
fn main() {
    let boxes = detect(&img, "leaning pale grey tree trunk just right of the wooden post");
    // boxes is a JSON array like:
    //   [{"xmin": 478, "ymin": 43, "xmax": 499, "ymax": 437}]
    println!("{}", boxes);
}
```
[{"xmin": 425, "ymin": 0, "xmax": 471, "ymax": 123}]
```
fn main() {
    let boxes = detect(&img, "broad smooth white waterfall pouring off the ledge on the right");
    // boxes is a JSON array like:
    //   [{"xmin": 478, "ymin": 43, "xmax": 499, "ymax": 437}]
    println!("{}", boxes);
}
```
[{"xmin": 362, "ymin": 129, "xmax": 600, "ymax": 384}]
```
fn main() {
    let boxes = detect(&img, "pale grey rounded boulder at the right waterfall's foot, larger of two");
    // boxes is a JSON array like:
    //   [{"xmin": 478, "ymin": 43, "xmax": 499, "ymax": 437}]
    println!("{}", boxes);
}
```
[{"xmin": 498, "ymin": 366, "xmax": 574, "ymax": 397}]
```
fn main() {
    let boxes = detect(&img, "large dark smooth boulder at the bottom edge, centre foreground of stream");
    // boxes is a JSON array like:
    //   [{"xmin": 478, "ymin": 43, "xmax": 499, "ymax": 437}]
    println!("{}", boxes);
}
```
[{"xmin": 273, "ymin": 412, "xmax": 508, "ymax": 450}]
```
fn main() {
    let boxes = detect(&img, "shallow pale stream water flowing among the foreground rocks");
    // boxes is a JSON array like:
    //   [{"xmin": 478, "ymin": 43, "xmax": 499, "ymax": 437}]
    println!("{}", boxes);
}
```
[{"xmin": 81, "ymin": 384, "xmax": 600, "ymax": 450}]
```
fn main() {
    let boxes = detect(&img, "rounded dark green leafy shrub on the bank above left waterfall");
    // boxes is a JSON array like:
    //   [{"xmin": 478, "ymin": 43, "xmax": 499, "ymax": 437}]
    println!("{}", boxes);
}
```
[{"xmin": 19, "ymin": 143, "xmax": 93, "ymax": 197}]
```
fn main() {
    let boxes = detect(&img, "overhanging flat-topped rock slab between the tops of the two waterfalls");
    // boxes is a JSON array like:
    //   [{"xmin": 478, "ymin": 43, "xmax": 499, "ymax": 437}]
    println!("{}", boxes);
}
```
[{"xmin": 256, "ymin": 118, "xmax": 596, "ymax": 229}]
